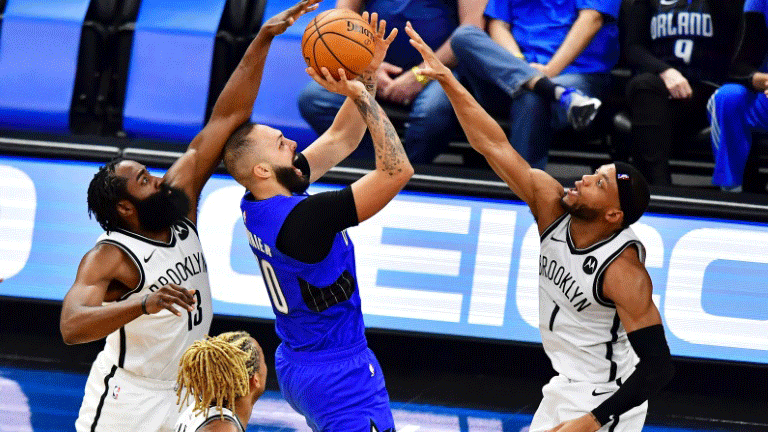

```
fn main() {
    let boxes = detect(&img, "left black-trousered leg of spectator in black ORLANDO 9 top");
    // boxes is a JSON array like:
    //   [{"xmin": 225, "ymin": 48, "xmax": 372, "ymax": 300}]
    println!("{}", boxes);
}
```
[{"xmin": 627, "ymin": 73, "xmax": 672, "ymax": 185}]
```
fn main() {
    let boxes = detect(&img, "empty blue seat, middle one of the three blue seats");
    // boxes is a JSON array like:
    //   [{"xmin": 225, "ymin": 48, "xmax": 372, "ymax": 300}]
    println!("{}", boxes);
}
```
[{"xmin": 123, "ymin": 0, "xmax": 226, "ymax": 142}]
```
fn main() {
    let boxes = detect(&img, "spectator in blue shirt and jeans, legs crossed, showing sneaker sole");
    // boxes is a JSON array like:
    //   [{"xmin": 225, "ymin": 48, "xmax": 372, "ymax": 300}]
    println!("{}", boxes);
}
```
[{"xmin": 451, "ymin": 0, "xmax": 620, "ymax": 169}]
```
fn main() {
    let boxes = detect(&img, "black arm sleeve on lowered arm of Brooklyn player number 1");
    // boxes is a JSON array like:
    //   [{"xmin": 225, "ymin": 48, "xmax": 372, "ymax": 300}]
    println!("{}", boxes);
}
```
[{"xmin": 592, "ymin": 324, "xmax": 675, "ymax": 425}]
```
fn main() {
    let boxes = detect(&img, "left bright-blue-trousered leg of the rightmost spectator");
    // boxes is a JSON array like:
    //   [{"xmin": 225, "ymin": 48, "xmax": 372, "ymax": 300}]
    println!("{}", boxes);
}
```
[{"xmin": 707, "ymin": 84, "xmax": 757, "ymax": 189}]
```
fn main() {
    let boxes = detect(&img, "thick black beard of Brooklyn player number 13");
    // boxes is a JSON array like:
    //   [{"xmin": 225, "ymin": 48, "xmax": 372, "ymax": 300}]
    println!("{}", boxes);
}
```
[{"xmin": 131, "ymin": 183, "xmax": 189, "ymax": 233}]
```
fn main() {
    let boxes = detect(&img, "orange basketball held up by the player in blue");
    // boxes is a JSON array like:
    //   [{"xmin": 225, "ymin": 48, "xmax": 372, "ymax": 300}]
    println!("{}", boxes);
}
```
[{"xmin": 301, "ymin": 9, "xmax": 375, "ymax": 79}]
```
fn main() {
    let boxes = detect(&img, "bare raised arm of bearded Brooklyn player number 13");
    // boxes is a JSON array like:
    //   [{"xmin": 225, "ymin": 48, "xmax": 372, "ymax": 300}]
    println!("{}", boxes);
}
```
[{"xmin": 164, "ymin": 0, "xmax": 320, "ymax": 220}]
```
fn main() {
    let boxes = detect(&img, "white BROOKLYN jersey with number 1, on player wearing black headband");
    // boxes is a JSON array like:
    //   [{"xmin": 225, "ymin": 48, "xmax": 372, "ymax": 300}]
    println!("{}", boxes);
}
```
[{"xmin": 539, "ymin": 213, "xmax": 645, "ymax": 383}]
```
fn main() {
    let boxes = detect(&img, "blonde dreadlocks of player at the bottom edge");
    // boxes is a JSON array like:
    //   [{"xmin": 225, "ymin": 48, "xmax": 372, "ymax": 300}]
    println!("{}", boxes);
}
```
[{"xmin": 176, "ymin": 331, "xmax": 261, "ymax": 416}]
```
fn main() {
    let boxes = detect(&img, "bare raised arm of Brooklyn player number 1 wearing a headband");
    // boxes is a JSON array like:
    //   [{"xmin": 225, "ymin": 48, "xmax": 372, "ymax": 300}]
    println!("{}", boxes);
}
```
[{"xmin": 405, "ymin": 23, "xmax": 563, "ymax": 230}]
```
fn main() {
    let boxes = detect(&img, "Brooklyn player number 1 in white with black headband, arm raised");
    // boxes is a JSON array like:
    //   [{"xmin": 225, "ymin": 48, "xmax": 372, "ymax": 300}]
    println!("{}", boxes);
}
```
[{"xmin": 405, "ymin": 25, "xmax": 674, "ymax": 432}]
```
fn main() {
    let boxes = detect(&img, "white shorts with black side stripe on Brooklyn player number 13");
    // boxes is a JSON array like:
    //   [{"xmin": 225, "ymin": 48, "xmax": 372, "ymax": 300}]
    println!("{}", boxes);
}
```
[{"xmin": 75, "ymin": 352, "xmax": 181, "ymax": 432}]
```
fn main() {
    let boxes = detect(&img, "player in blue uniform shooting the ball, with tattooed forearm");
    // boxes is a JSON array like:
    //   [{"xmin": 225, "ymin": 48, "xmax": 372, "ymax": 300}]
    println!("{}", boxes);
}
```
[{"xmin": 224, "ymin": 13, "xmax": 413, "ymax": 432}]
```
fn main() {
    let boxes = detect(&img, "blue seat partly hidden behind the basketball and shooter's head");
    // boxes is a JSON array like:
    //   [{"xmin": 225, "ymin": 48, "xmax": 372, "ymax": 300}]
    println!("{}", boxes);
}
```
[{"xmin": 246, "ymin": 0, "xmax": 334, "ymax": 149}]
